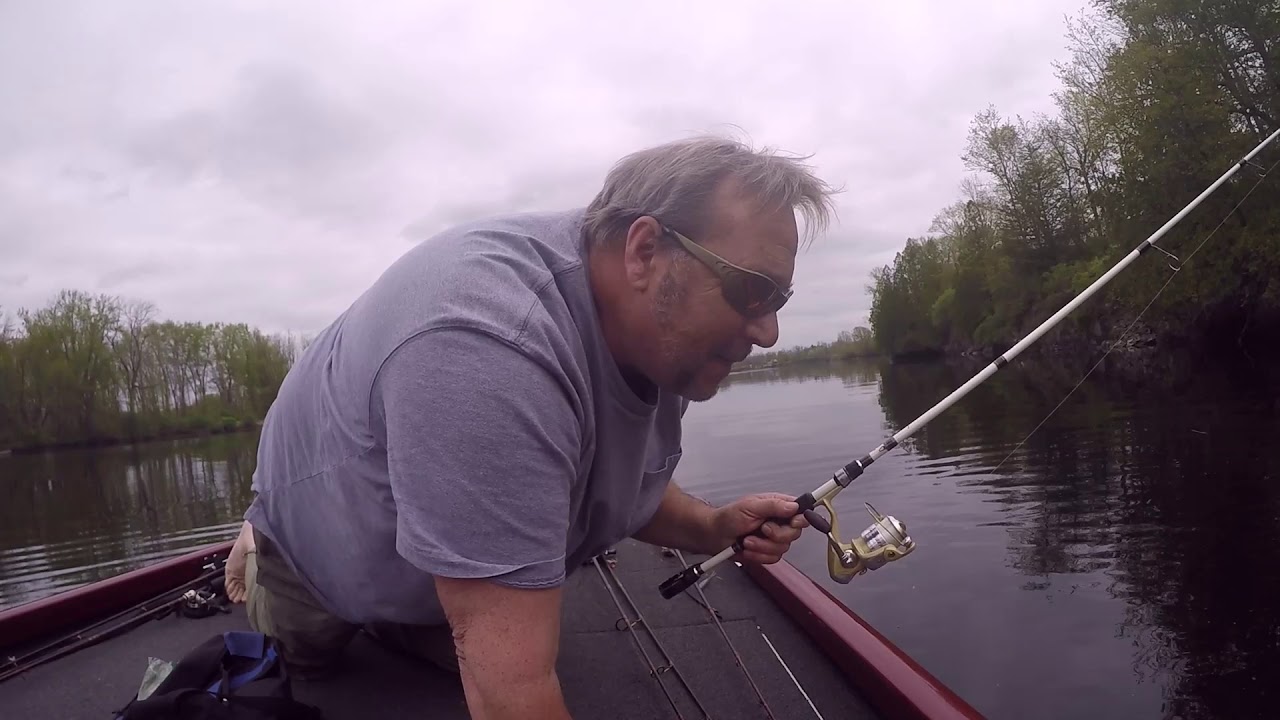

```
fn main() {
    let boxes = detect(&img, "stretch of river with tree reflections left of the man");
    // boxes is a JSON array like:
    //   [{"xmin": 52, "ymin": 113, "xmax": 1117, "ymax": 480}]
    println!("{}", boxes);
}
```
[{"xmin": 0, "ymin": 432, "xmax": 257, "ymax": 607}]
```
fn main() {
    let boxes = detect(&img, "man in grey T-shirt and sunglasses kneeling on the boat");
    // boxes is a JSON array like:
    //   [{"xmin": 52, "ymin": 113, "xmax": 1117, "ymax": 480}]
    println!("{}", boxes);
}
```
[{"xmin": 228, "ymin": 137, "xmax": 831, "ymax": 720}]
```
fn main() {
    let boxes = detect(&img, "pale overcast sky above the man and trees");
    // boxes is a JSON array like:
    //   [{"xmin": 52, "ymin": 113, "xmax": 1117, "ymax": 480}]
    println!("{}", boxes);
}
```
[{"xmin": 0, "ymin": 0, "xmax": 1085, "ymax": 348}]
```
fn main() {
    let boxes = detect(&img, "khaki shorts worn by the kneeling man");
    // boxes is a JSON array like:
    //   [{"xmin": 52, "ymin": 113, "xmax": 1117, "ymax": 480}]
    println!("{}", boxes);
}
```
[{"xmin": 244, "ymin": 529, "xmax": 458, "ymax": 678}]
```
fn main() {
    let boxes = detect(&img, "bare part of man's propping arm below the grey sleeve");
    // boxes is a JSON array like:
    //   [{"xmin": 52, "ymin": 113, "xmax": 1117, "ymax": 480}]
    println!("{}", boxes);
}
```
[{"xmin": 435, "ymin": 578, "xmax": 570, "ymax": 720}]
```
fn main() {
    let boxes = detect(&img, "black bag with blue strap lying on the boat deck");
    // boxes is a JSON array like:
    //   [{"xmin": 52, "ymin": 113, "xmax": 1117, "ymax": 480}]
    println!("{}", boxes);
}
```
[{"xmin": 115, "ymin": 632, "xmax": 323, "ymax": 720}]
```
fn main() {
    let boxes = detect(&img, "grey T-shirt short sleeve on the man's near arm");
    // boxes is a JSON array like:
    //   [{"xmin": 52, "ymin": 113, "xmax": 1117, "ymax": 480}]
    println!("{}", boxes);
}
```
[{"xmin": 371, "ymin": 329, "xmax": 582, "ymax": 587}]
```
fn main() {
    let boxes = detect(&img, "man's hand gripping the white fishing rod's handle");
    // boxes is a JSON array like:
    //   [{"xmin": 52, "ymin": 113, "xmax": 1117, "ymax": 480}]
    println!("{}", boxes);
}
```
[{"xmin": 710, "ymin": 492, "xmax": 809, "ymax": 565}]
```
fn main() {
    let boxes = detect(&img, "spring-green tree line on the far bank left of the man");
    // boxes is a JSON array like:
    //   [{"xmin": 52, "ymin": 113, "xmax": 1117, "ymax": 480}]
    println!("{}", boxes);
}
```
[{"xmin": 0, "ymin": 290, "xmax": 300, "ymax": 448}]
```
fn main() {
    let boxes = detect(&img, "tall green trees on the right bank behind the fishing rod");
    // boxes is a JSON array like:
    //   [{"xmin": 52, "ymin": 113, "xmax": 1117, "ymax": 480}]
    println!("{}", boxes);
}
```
[{"xmin": 869, "ymin": 0, "xmax": 1280, "ymax": 363}]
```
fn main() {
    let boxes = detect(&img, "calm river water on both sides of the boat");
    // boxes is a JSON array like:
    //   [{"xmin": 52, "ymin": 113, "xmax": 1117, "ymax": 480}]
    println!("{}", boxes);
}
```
[{"xmin": 0, "ymin": 363, "xmax": 1280, "ymax": 720}]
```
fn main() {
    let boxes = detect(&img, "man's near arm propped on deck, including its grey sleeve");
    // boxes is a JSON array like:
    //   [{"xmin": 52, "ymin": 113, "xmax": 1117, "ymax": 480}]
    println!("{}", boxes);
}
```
[{"xmin": 371, "ymin": 329, "xmax": 581, "ymax": 720}]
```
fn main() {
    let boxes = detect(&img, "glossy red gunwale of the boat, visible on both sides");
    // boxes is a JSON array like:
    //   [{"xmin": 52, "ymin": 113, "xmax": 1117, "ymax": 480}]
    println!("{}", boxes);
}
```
[{"xmin": 0, "ymin": 541, "xmax": 983, "ymax": 720}]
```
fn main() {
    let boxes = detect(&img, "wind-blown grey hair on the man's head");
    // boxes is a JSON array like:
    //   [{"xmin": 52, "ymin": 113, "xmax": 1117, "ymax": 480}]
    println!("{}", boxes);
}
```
[{"xmin": 584, "ymin": 136, "xmax": 837, "ymax": 251}]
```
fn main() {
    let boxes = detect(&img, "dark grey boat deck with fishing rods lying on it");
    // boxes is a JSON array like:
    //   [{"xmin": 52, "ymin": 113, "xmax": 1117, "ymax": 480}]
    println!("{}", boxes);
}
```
[{"xmin": 0, "ymin": 542, "xmax": 879, "ymax": 720}]
